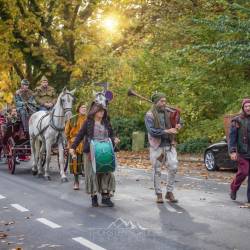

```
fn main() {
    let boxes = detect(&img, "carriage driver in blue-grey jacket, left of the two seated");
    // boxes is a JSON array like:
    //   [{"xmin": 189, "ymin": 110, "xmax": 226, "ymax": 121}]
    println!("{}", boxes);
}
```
[{"xmin": 15, "ymin": 79, "xmax": 37, "ymax": 134}]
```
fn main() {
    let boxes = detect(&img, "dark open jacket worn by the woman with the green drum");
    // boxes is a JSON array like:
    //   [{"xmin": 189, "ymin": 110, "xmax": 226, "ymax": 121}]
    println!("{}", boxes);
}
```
[{"xmin": 71, "ymin": 119, "xmax": 116, "ymax": 153}]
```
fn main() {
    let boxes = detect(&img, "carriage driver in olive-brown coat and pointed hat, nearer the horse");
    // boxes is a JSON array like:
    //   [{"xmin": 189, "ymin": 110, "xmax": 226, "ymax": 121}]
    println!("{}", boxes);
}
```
[{"xmin": 34, "ymin": 76, "xmax": 57, "ymax": 111}]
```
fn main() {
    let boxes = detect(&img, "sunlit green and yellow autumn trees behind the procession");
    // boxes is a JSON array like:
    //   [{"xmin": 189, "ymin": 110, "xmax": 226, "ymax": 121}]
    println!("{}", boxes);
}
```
[{"xmin": 0, "ymin": 0, "xmax": 250, "ymax": 152}]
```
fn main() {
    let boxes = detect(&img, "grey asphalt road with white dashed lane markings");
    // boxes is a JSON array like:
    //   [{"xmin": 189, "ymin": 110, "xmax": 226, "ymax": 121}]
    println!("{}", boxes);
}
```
[{"xmin": 0, "ymin": 160, "xmax": 250, "ymax": 250}]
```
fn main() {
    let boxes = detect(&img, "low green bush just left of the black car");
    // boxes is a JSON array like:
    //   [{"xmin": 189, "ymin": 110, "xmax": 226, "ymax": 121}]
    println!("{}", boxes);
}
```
[{"xmin": 177, "ymin": 138, "xmax": 210, "ymax": 153}]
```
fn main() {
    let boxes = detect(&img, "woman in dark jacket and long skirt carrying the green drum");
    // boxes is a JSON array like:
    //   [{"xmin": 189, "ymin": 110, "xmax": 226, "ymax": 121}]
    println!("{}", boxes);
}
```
[{"xmin": 70, "ymin": 103, "xmax": 119, "ymax": 207}]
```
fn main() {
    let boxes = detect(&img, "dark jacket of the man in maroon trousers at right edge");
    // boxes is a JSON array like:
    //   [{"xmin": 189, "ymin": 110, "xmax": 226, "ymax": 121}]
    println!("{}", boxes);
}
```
[{"xmin": 228, "ymin": 113, "xmax": 250, "ymax": 159}]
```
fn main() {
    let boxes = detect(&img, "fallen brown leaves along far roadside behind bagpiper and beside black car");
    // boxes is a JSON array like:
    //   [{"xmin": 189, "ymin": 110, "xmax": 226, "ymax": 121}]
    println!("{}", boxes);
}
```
[{"xmin": 117, "ymin": 150, "xmax": 235, "ymax": 183}]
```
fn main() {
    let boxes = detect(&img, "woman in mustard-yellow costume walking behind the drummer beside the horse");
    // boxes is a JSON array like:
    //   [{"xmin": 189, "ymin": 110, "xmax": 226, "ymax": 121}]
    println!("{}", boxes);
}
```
[{"xmin": 65, "ymin": 102, "xmax": 86, "ymax": 190}]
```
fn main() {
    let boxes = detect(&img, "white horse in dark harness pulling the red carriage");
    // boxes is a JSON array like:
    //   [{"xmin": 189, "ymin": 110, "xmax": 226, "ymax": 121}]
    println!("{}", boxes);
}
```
[{"xmin": 29, "ymin": 88, "xmax": 75, "ymax": 182}]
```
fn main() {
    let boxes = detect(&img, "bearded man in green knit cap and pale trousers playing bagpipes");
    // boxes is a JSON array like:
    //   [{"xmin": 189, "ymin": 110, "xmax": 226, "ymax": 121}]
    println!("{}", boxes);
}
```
[{"xmin": 145, "ymin": 93, "xmax": 181, "ymax": 203}]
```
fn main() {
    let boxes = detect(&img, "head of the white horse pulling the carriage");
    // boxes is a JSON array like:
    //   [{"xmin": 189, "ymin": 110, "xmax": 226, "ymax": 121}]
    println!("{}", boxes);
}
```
[{"xmin": 59, "ymin": 87, "xmax": 76, "ymax": 121}]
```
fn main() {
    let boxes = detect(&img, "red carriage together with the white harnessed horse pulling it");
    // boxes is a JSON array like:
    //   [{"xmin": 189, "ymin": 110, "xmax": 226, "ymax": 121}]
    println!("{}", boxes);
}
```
[{"xmin": 0, "ymin": 88, "xmax": 72, "ymax": 178}]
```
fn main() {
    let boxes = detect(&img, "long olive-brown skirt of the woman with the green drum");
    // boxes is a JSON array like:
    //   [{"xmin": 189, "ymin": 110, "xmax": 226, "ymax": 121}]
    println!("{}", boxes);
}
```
[{"xmin": 84, "ymin": 154, "xmax": 116, "ymax": 196}]
